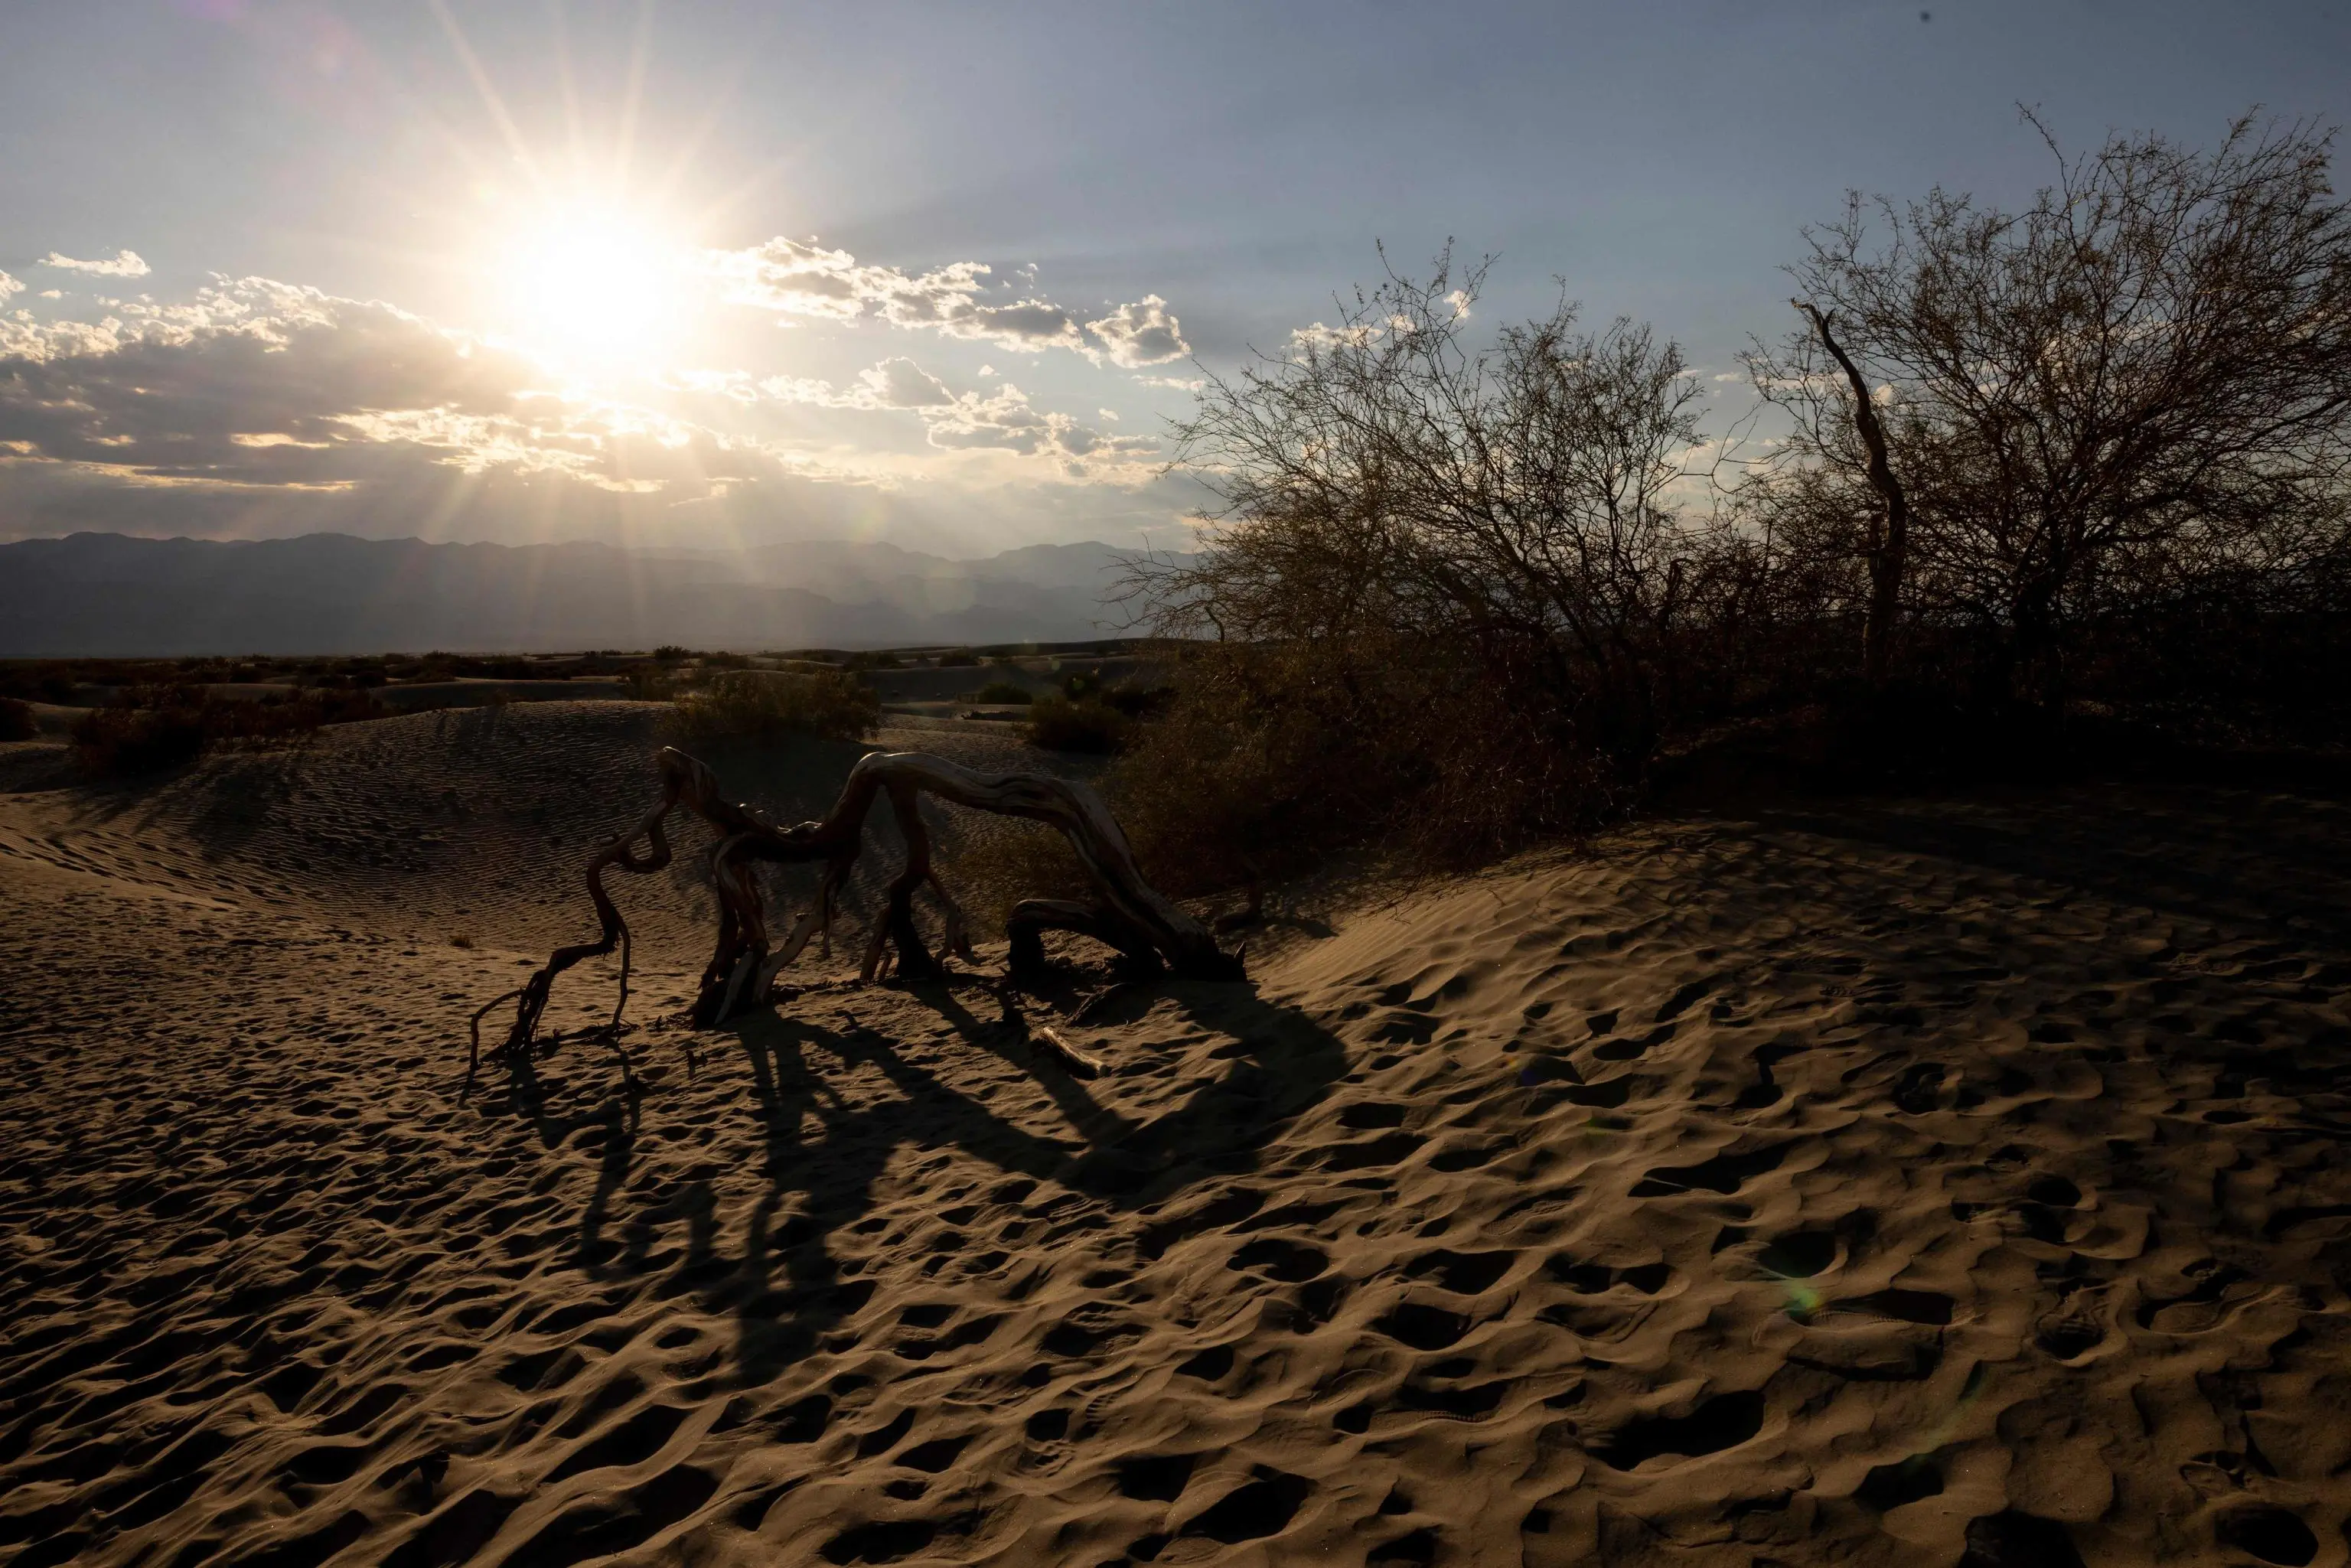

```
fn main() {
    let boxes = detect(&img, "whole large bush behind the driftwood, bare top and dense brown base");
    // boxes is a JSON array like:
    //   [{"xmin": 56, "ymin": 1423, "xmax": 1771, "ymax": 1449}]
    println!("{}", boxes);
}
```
[{"xmin": 1119, "ymin": 259, "xmax": 1733, "ymax": 879}]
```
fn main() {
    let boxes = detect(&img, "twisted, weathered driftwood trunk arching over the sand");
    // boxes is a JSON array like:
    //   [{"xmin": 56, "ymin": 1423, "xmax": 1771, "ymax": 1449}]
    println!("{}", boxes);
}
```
[{"xmin": 475, "ymin": 745, "xmax": 1241, "ymax": 1060}]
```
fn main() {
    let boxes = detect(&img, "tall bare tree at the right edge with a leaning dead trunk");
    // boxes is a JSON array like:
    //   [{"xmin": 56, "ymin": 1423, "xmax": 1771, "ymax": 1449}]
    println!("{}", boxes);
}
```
[{"xmin": 1746, "ymin": 116, "xmax": 2351, "ymax": 703}]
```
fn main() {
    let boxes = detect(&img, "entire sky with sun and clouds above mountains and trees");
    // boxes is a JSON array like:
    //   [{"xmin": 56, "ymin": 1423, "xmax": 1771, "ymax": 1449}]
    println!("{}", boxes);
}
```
[{"xmin": 0, "ymin": 0, "xmax": 2351, "ymax": 555}]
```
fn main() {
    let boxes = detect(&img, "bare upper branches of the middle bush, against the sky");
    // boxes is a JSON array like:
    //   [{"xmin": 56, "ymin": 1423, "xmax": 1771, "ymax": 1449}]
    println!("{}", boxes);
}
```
[{"xmin": 1138, "ymin": 256, "xmax": 1700, "ymax": 757}]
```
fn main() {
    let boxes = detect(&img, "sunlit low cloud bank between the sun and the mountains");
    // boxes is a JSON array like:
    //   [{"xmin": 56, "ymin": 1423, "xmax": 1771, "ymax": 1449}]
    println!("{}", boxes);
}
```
[{"xmin": 0, "ymin": 263, "xmax": 1185, "ymax": 541}]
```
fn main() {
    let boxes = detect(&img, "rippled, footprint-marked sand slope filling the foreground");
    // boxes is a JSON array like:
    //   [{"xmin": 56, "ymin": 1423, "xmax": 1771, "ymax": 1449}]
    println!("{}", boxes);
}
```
[{"xmin": 0, "ymin": 708, "xmax": 2351, "ymax": 1568}]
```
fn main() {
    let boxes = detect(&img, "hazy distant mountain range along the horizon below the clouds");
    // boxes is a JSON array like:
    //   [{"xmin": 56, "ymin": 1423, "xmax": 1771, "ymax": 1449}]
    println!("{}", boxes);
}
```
[{"xmin": 0, "ymin": 533, "xmax": 1176, "ymax": 658}]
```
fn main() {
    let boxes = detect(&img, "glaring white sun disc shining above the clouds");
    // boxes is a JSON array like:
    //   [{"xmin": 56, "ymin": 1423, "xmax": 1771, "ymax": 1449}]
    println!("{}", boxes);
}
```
[{"xmin": 489, "ymin": 202, "xmax": 689, "ymax": 369}]
